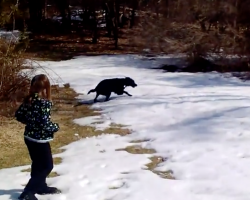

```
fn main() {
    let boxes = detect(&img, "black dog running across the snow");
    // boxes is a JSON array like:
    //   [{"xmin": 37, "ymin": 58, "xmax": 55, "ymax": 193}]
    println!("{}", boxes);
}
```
[{"xmin": 88, "ymin": 77, "xmax": 137, "ymax": 102}]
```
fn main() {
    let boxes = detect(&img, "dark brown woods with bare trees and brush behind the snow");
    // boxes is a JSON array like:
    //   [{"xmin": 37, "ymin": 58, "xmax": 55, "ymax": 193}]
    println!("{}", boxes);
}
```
[{"xmin": 0, "ymin": 0, "xmax": 250, "ymax": 55}]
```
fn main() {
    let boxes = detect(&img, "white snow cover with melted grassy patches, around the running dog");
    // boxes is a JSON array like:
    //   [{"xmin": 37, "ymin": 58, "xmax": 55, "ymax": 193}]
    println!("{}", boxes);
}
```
[{"xmin": 0, "ymin": 56, "xmax": 250, "ymax": 200}]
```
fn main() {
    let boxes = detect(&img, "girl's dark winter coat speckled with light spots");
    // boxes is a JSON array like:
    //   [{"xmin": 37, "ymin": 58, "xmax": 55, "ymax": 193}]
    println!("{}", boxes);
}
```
[{"xmin": 15, "ymin": 94, "xmax": 59, "ymax": 143}]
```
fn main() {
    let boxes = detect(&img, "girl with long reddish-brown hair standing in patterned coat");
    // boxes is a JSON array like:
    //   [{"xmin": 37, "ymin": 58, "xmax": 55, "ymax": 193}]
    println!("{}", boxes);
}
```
[{"xmin": 15, "ymin": 74, "xmax": 60, "ymax": 200}]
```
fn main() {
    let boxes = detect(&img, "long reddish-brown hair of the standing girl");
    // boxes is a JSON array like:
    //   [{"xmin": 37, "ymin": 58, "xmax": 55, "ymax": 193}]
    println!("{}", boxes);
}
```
[{"xmin": 24, "ymin": 74, "xmax": 51, "ymax": 104}]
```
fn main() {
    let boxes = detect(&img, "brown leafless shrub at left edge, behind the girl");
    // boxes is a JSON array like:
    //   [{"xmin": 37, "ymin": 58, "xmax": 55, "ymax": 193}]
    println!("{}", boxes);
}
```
[{"xmin": 0, "ymin": 32, "xmax": 32, "ymax": 108}]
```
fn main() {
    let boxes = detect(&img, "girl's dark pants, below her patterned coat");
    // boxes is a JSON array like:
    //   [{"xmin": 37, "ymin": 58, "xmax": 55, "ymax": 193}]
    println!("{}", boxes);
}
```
[{"xmin": 24, "ymin": 139, "xmax": 53, "ymax": 194}]
